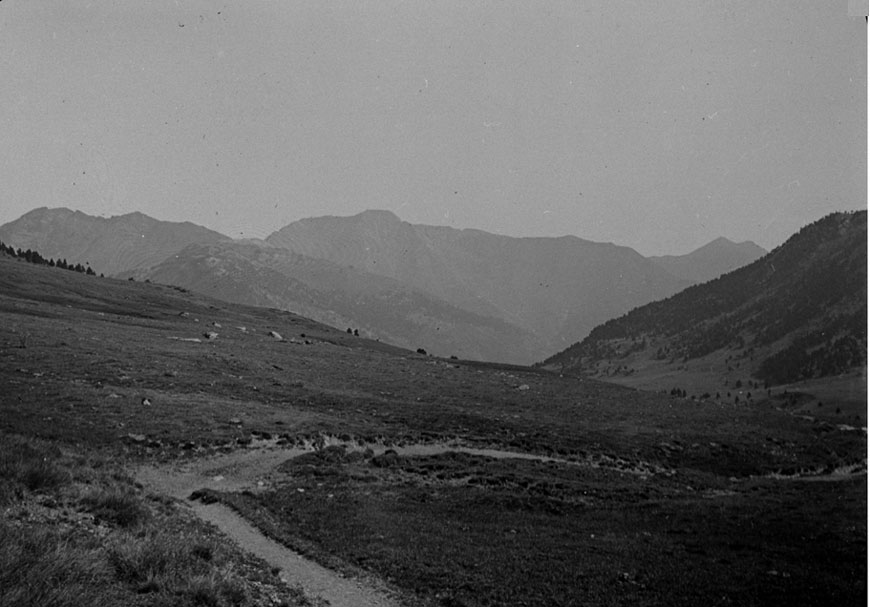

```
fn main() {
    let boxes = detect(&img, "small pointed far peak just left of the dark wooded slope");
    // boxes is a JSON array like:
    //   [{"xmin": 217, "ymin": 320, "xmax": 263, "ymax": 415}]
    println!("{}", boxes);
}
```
[{"xmin": 648, "ymin": 238, "xmax": 767, "ymax": 282}]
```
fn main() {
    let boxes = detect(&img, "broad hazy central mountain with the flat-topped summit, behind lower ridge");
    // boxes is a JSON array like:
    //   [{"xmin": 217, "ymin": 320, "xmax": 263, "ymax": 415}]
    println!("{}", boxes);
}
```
[{"xmin": 266, "ymin": 211, "xmax": 691, "ymax": 358}]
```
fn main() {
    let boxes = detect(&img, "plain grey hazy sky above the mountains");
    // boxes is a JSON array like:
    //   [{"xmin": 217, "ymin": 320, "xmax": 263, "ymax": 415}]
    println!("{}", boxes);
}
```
[{"xmin": 0, "ymin": 0, "xmax": 867, "ymax": 255}]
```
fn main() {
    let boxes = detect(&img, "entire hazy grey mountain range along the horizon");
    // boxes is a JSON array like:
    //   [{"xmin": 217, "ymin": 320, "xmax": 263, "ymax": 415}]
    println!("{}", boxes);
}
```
[{"xmin": 0, "ymin": 208, "xmax": 764, "ymax": 364}]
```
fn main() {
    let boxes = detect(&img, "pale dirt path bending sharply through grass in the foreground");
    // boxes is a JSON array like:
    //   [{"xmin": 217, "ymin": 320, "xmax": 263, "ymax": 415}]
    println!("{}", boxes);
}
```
[{"xmin": 136, "ymin": 449, "xmax": 400, "ymax": 607}]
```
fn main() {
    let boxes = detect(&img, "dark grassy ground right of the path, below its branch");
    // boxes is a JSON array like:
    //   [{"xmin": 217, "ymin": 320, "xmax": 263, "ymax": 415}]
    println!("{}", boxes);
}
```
[{"xmin": 208, "ymin": 448, "xmax": 866, "ymax": 606}]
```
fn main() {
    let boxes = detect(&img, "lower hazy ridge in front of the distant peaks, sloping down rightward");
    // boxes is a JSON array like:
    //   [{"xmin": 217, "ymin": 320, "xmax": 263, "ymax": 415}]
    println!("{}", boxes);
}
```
[{"xmin": 121, "ymin": 242, "xmax": 542, "ymax": 363}]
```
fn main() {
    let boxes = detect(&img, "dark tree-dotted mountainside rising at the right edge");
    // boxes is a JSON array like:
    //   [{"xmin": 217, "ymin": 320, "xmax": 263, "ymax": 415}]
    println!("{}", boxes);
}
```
[{"xmin": 542, "ymin": 211, "xmax": 867, "ymax": 384}]
